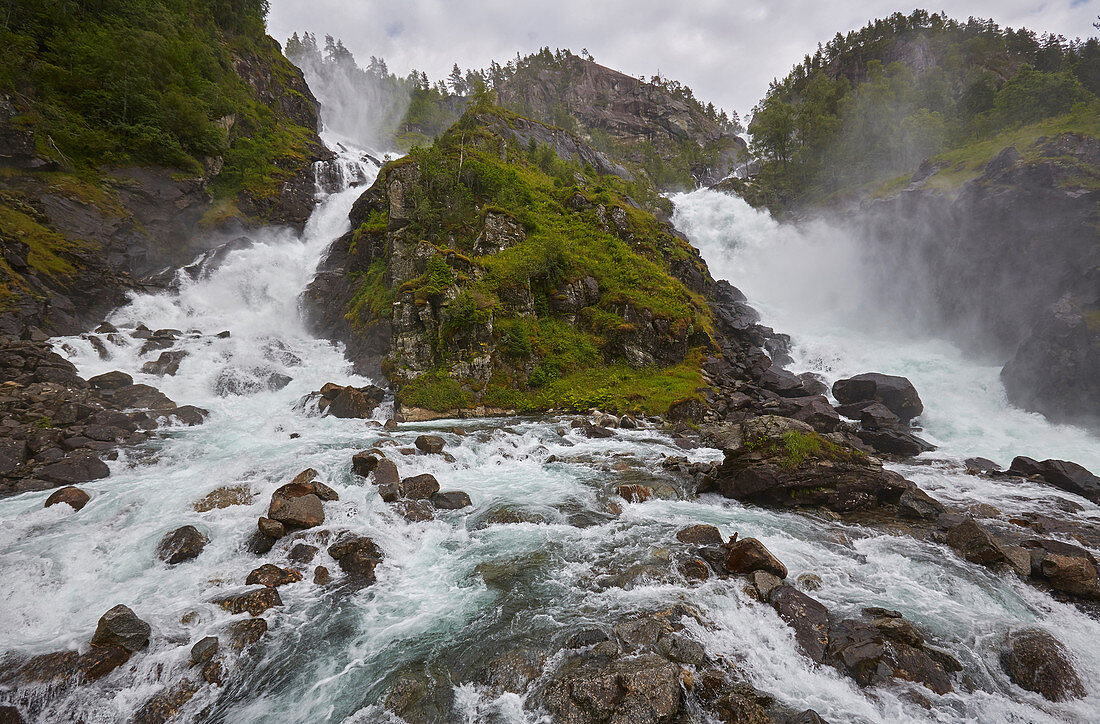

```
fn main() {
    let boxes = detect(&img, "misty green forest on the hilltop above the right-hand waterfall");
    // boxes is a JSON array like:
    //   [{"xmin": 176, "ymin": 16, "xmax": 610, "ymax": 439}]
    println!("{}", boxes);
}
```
[{"xmin": 749, "ymin": 10, "xmax": 1100, "ymax": 208}]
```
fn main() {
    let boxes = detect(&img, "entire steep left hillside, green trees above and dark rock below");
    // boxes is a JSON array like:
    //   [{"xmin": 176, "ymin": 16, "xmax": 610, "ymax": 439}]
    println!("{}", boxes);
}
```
[{"xmin": 0, "ymin": 0, "xmax": 328, "ymax": 334}]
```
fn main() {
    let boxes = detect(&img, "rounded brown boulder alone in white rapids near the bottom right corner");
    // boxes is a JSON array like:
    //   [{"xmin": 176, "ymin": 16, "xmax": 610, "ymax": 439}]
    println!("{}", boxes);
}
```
[{"xmin": 1001, "ymin": 628, "xmax": 1086, "ymax": 701}]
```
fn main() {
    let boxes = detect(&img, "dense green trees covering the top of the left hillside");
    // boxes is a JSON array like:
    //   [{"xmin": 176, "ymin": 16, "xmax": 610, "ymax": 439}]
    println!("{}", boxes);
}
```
[{"xmin": 0, "ymin": 0, "xmax": 321, "ymax": 198}]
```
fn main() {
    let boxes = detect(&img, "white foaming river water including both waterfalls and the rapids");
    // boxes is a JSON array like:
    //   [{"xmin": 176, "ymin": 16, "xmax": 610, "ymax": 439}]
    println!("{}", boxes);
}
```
[{"xmin": 0, "ymin": 148, "xmax": 1100, "ymax": 724}]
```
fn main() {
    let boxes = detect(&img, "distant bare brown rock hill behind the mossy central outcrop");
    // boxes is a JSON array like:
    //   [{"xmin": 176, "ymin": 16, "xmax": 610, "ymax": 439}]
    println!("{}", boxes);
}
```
[{"xmin": 496, "ymin": 54, "xmax": 745, "ymax": 187}]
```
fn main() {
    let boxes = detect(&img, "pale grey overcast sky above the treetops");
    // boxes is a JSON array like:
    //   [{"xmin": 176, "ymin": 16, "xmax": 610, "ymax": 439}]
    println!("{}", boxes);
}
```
[{"xmin": 267, "ymin": 0, "xmax": 1100, "ymax": 116}]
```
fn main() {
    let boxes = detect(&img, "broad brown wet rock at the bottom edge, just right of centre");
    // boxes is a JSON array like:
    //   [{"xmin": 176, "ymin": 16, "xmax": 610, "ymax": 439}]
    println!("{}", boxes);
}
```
[{"xmin": 542, "ymin": 655, "xmax": 682, "ymax": 724}]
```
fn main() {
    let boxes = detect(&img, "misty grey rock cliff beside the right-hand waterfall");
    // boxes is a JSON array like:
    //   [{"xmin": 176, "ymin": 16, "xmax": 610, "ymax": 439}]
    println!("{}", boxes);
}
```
[{"xmin": 856, "ymin": 133, "xmax": 1100, "ymax": 426}]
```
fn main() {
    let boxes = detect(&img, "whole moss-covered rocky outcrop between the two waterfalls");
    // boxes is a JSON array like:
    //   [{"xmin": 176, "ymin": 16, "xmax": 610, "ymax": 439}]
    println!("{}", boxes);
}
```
[{"xmin": 306, "ymin": 109, "xmax": 783, "ymax": 419}]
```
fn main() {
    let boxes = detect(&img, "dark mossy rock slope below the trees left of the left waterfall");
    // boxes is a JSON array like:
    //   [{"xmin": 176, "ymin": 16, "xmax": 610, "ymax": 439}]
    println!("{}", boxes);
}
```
[{"xmin": 0, "ymin": 37, "xmax": 330, "ymax": 336}]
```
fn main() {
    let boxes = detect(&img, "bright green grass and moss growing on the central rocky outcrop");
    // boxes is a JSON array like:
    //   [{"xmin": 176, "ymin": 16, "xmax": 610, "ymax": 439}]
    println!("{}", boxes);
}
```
[{"xmin": 360, "ymin": 105, "xmax": 712, "ymax": 413}]
